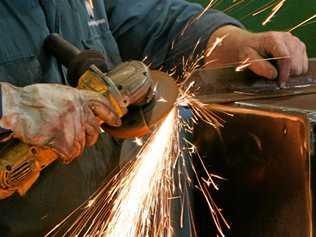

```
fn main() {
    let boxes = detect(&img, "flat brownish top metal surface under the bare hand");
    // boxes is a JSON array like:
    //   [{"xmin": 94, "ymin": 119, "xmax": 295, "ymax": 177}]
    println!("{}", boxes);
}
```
[{"xmin": 191, "ymin": 59, "xmax": 316, "ymax": 103}]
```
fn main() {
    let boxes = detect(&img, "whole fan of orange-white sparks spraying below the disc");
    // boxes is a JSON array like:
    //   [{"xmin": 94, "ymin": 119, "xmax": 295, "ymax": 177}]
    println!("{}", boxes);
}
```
[{"xmin": 46, "ymin": 82, "xmax": 230, "ymax": 237}]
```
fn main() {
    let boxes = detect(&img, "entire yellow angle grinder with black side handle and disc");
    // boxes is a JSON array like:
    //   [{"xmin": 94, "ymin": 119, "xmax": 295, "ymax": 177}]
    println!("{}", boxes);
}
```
[{"xmin": 0, "ymin": 34, "xmax": 178, "ymax": 199}]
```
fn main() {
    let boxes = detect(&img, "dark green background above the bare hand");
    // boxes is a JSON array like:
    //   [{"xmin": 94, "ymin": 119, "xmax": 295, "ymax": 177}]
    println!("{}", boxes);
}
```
[{"xmin": 191, "ymin": 0, "xmax": 316, "ymax": 57}]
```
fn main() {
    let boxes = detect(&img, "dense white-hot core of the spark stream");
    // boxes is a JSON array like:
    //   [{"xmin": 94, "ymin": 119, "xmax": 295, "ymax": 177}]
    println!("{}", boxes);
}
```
[{"xmin": 104, "ymin": 108, "xmax": 177, "ymax": 237}]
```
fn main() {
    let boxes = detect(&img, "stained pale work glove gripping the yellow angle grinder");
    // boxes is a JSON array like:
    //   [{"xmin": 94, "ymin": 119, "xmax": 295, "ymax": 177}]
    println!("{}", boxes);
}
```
[{"xmin": 0, "ymin": 83, "xmax": 121, "ymax": 162}]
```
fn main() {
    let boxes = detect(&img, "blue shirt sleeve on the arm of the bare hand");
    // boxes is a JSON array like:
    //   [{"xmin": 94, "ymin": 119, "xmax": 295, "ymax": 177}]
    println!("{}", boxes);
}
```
[{"xmin": 107, "ymin": 0, "xmax": 241, "ymax": 69}]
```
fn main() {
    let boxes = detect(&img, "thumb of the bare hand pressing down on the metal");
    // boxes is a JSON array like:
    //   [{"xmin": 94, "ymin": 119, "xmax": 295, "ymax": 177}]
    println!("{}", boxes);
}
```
[{"xmin": 243, "ymin": 48, "xmax": 278, "ymax": 79}]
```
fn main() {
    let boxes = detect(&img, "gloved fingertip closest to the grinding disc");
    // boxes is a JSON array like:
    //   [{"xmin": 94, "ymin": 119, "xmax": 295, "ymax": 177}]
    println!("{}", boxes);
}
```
[{"xmin": 89, "ymin": 101, "xmax": 122, "ymax": 127}]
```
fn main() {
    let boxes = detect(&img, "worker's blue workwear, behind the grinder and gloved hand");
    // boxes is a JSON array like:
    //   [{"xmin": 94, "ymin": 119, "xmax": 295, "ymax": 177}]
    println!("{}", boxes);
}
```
[{"xmin": 0, "ymin": 0, "xmax": 239, "ymax": 236}]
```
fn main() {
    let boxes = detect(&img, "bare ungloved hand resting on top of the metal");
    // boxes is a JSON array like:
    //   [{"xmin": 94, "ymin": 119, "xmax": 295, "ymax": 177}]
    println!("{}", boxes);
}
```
[{"xmin": 205, "ymin": 26, "xmax": 308, "ymax": 85}]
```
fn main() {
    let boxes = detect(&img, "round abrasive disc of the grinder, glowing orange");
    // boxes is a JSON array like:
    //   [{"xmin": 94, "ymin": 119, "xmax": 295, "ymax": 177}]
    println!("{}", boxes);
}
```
[{"xmin": 102, "ymin": 71, "xmax": 178, "ymax": 138}]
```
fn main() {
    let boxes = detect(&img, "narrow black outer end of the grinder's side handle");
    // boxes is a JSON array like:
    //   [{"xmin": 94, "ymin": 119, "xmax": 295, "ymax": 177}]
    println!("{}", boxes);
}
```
[{"xmin": 44, "ymin": 33, "xmax": 81, "ymax": 68}]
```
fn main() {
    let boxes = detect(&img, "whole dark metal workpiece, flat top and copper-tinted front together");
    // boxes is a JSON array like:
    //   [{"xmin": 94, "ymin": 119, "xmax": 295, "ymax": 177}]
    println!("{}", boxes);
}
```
[{"xmin": 188, "ymin": 59, "xmax": 316, "ymax": 237}]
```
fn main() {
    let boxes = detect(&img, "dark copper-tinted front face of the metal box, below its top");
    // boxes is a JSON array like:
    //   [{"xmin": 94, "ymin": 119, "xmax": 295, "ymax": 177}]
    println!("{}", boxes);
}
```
[{"xmin": 194, "ymin": 109, "xmax": 315, "ymax": 237}]
